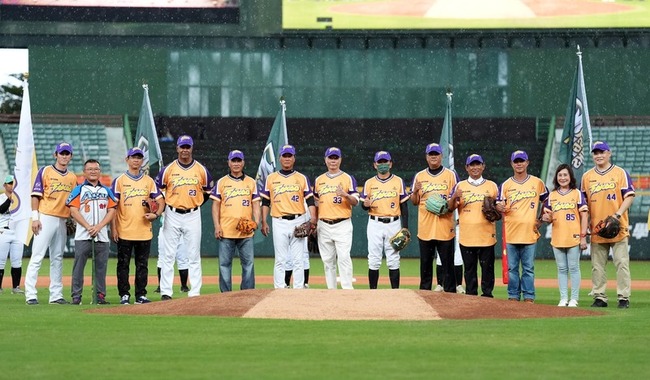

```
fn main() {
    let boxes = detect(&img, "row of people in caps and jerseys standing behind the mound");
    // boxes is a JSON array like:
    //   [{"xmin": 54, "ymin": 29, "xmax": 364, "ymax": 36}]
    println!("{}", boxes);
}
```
[{"xmin": 4, "ymin": 136, "xmax": 634, "ymax": 308}]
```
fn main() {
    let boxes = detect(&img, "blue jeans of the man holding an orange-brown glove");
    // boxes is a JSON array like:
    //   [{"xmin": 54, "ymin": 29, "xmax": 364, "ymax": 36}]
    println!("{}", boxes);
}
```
[{"xmin": 219, "ymin": 238, "xmax": 255, "ymax": 292}]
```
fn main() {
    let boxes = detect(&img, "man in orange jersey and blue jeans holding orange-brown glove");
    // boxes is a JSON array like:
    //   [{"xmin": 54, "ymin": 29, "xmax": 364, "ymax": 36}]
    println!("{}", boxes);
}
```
[{"xmin": 210, "ymin": 150, "xmax": 260, "ymax": 292}]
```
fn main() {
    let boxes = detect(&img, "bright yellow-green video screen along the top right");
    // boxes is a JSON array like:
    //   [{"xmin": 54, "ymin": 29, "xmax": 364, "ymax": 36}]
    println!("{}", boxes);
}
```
[{"xmin": 282, "ymin": 0, "xmax": 650, "ymax": 30}]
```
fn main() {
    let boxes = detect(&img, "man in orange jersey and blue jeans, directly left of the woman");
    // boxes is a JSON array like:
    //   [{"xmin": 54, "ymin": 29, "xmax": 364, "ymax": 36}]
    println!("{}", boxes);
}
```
[{"xmin": 497, "ymin": 150, "xmax": 548, "ymax": 303}]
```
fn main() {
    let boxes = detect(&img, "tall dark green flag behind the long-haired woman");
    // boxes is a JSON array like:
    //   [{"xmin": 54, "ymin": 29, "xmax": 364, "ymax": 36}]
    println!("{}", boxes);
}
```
[{"xmin": 558, "ymin": 46, "xmax": 591, "ymax": 183}]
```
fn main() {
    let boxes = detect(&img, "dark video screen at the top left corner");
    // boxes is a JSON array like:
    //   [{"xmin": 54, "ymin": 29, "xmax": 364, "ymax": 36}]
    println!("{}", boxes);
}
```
[{"xmin": 0, "ymin": 0, "xmax": 240, "ymax": 24}]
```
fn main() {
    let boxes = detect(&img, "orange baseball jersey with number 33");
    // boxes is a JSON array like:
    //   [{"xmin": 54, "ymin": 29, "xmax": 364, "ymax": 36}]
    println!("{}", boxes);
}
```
[{"xmin": 314, "ymin": 172, "xmax": 359, "ymax": 220}]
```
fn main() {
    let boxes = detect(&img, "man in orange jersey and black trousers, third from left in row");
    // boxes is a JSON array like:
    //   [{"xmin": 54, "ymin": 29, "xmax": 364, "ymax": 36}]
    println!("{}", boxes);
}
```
[{"xmin": 111, "ymin": 147, "xmax": 165, "ymax": 305}]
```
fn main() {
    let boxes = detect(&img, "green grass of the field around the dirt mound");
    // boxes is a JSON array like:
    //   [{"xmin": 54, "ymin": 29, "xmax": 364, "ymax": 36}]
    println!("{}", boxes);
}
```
[{"xmin": 0, "ymin": 258, "xmax": 650, "ymax": 379}]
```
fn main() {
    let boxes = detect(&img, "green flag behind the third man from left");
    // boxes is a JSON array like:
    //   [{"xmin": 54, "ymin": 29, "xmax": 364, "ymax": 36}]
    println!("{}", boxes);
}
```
[{"xmin": 133, "ymin": 84, "xmax": 163, "ymax": 176}]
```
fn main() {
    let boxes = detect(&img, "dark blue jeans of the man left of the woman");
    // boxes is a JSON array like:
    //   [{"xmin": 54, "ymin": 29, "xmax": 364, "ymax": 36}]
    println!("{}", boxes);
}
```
[{"xmin": 506, "ymin": 243, "xmax": 536, "ymax": 300}]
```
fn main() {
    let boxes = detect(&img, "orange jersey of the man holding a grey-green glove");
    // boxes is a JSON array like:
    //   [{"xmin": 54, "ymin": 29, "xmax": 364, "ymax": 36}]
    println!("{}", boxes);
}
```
[{"xmin": 411, "ymin": 168, "xmax": 458, "ymax": 241}]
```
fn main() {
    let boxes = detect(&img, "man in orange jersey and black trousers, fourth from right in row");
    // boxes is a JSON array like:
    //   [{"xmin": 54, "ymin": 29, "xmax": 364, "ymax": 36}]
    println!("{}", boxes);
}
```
[{"xmin": 449, "ymin": 154, "xmax": 499, "ymax": 298}]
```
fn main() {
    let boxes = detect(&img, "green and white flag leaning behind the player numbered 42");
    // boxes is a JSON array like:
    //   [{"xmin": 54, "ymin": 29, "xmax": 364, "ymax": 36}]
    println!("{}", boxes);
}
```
[{"xmin": 255, "ymin": 97, "xmax": 289, "ymax": 191}]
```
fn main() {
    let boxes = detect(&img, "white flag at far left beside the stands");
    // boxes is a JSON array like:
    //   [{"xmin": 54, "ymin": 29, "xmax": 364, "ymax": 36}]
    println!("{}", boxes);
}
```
[{"xmin": 10, "ymin": 80, "xmax": 38, "ymax": 245}]
